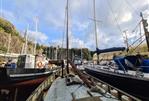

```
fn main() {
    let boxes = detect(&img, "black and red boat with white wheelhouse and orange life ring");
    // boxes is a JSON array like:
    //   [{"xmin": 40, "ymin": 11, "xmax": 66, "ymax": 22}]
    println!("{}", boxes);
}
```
[{"xmin": 0, "ymin": 23, "xmax": 58, "ymax": 101}]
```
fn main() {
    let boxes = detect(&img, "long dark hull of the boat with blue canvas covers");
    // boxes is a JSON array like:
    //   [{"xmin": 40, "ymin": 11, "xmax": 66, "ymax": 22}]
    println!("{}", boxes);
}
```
[{"xmin": 85, "ymin": 68, "xmax": 149, "ymax": 101}]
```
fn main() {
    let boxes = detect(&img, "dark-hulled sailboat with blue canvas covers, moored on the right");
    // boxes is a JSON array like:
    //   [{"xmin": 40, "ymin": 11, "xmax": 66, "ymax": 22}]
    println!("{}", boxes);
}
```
[{"xmin": 85, "ymin": 4, "xmax": 149, "ymax": 101}]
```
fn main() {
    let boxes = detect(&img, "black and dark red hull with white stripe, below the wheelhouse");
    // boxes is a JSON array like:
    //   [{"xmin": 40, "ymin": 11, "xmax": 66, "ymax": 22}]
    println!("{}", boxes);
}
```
[{"xmin": 0, "ymin": 68, "xmax": 52, "ymax": 101}]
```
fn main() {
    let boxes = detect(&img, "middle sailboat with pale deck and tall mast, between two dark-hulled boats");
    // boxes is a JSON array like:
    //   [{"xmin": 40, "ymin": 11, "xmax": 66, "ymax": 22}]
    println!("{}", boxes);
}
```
[{"xmin": 27, "ymin": 0, "xmax": 141, "ymax": 101}]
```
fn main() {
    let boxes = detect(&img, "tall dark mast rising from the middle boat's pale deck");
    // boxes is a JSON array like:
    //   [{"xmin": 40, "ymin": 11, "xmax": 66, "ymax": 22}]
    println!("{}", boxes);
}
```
[{"xmin": 66, "ymin": 0, "xmax": 69, "ymax": 74}]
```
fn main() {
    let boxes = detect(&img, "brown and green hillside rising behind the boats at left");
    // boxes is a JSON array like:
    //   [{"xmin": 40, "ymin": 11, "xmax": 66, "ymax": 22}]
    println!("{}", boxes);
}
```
[{"xmin": 0, "ymin": 18, "xmax": 39, "ymax": 53}]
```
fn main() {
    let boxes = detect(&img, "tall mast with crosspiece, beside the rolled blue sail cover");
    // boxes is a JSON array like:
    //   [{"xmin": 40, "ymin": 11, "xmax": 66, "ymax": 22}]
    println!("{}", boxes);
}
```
[{"xmin": 93, "ymin": 0, "xmax": 99, "ymax": 64}]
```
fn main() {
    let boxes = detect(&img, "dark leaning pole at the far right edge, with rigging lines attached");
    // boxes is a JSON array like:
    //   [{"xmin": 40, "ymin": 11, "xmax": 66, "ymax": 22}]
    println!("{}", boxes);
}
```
[{"xmin": 140, "ymin": 12, "xmax": 149, "ymax": 51}]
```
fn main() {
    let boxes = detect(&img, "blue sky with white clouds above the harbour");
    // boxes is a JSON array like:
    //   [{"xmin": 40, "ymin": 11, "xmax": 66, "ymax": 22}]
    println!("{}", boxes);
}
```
[{"xmin": 0, "ymin": 0, "xmax": 149, "ymax": 50}]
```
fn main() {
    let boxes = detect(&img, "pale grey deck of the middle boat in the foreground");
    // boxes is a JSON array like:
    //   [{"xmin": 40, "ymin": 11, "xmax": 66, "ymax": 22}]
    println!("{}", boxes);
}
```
[{"xmin": 44, "ymin": 76, "xmax": 118, "ymax": 101}]
